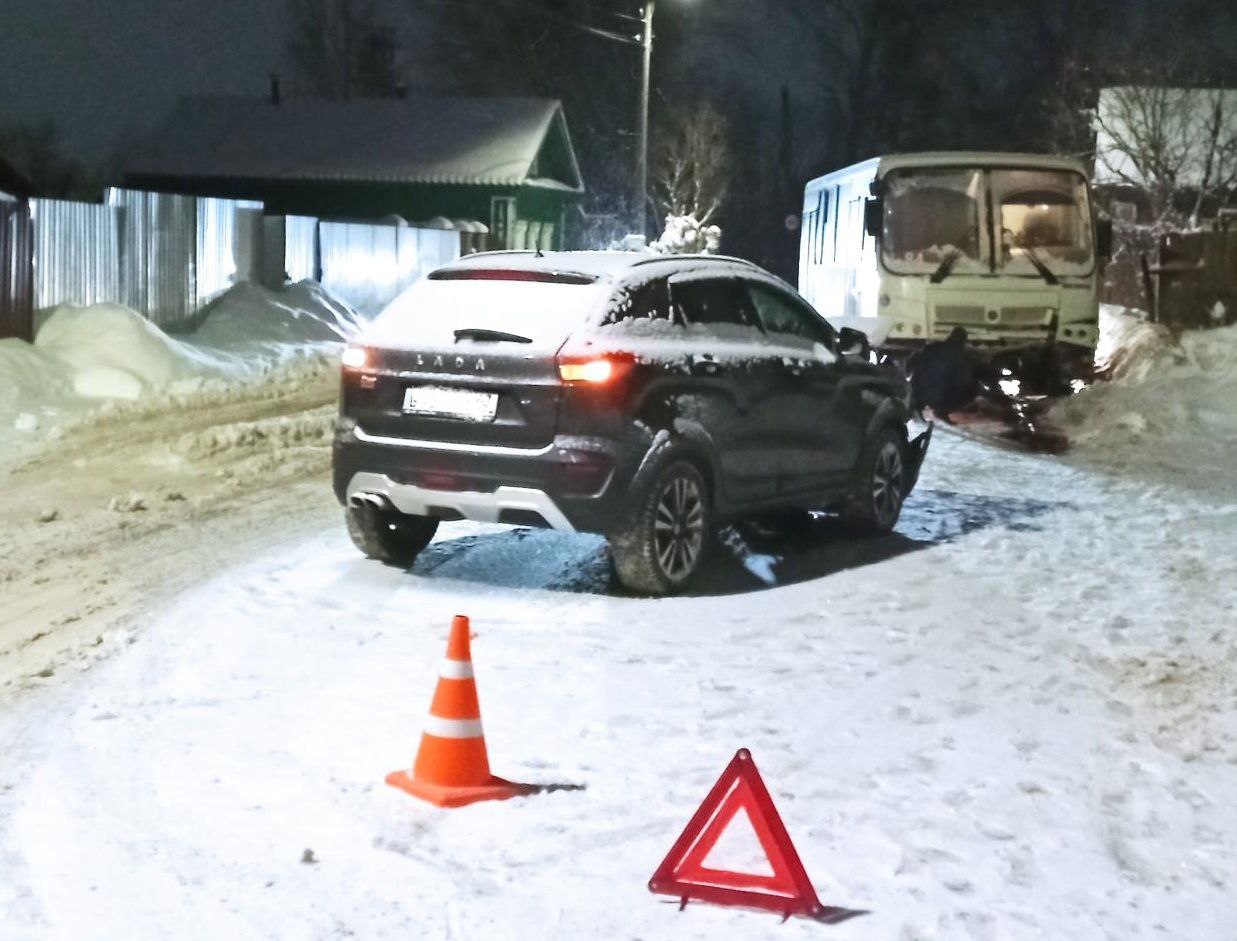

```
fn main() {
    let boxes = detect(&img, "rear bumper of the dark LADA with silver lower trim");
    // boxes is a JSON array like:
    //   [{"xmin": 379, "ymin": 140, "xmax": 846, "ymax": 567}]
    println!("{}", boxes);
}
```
[{"xmin": 333, "ymin": 420, "xmax": 643, "ymax": 533}]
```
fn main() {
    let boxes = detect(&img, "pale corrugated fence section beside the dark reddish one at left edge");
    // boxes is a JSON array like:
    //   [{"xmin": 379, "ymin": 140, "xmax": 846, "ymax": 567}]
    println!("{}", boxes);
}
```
[{"xmin": 30, "ymin": 199, "xmax": 120, "ymax": 309}]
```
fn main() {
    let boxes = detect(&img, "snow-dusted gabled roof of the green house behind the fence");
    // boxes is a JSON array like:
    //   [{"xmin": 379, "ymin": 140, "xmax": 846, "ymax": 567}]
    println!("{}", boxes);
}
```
[{"xmin": 126, "ymin": 96, "xmax": 584, "ymax": 192}]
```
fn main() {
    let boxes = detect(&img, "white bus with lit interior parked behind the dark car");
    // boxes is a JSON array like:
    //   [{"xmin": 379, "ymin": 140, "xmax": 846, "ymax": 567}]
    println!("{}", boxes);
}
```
[{"xmin": 799, "ymin": 152, "xmax": 1112, "ymax": 371}]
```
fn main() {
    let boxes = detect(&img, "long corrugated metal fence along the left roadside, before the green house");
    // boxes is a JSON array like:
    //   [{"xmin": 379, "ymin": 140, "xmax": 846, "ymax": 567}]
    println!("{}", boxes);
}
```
[{"xmin": 0, "ymin": 188, "xmax": 460, "ymax": 339}]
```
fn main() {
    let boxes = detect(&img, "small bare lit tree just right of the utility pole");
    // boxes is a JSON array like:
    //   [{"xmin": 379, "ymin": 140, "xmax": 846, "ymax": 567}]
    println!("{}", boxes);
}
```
[{"xmin": 652, "ymin": 105, "xmax": 730, "ymax": 225}]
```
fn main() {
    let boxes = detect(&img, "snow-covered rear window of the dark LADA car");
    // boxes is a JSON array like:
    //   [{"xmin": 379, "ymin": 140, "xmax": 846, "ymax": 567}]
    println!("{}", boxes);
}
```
[{"xmin": 362, "ymin": 277, "xmax": 606, "ymax": 350}]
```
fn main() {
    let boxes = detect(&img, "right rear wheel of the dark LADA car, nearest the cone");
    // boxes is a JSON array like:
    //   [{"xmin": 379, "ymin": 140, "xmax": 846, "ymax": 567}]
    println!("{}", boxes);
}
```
[{"xmin": 610, "ymin": 455, "xmax": 714, "ymax": 596}]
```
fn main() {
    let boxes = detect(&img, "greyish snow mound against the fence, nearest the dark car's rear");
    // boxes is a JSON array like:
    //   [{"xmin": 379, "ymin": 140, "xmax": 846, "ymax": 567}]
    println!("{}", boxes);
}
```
[{"xmin": 193, "ymin": 281, "xmax": 361, "ymax": 352}]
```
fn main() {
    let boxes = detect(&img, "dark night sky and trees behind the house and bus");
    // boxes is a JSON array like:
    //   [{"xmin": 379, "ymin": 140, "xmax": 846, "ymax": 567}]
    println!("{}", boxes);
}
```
[{"xmin": 0, "ymin": 0, "xmax": 1237, "ymax": 273}]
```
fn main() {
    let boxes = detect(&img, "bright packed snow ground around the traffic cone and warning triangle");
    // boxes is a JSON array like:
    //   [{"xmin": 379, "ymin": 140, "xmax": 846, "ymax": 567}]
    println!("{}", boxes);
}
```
[{"xmin": 0, "ymin": 435, "xmax": 1237, "ymax": 940}]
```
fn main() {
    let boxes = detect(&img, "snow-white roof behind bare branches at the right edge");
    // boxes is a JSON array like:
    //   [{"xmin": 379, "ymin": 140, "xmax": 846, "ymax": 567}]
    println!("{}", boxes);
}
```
[{"xmin": 1094, "ymin": 85, "xmax": 1237, "ymax": 187}]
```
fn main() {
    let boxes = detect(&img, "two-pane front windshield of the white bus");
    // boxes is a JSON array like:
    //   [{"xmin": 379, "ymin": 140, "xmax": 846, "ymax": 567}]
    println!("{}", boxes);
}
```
[{"xmin": 881, "ymin": 168, "xmax": 1094, "ymax": 277}]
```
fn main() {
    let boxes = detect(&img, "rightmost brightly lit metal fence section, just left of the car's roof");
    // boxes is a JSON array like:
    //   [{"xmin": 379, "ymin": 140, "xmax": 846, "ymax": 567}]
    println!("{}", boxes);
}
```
[{"xmin": 318, "ymin": 223, "xmax": 460, "ymax": 315}]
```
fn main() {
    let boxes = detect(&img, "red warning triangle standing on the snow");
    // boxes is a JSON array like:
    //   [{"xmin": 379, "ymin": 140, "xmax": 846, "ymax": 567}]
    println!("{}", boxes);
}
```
[{"xmin": 648, "ymin": 748, "xmax": 829, "ymax": 919}]
